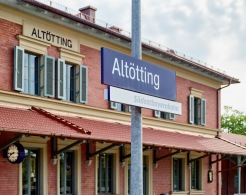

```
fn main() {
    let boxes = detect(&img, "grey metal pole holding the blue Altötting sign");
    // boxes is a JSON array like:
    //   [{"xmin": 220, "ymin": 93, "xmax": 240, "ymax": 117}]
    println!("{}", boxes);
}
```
[{"xmin": 130, "ymin": 0, "xmax": 143, "ymax": 195}]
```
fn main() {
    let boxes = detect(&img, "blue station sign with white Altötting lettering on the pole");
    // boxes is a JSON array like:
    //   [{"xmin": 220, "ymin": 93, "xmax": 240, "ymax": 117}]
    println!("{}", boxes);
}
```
[{"xmin": 101, "ymin": 48, "xmax": 176, "ymax": 101}]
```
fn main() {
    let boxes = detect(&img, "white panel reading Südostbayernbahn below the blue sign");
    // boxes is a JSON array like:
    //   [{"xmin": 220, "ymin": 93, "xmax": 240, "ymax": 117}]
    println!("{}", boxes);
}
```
[{"xmin": 108, "ymin": 86, "xmax": 182, "ymax": 115}]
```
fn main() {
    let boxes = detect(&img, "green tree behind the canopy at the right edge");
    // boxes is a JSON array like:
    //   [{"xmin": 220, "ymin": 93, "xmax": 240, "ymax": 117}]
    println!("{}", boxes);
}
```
[{"xmin": 221, "ymin": 106, "xmax": 246, "ymax": 135}]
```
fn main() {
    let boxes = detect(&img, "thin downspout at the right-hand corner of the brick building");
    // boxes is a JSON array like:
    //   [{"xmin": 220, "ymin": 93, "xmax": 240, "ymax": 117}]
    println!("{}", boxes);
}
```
[{"xmin": 216, "ymin": 78, "xmax": 232, "ymax": 194}]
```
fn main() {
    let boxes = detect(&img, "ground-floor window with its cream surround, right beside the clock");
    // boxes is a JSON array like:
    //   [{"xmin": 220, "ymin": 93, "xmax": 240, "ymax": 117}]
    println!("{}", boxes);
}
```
[{"xmin": 19, "ymin": 136, "xmax": 48, "ymax": 195}]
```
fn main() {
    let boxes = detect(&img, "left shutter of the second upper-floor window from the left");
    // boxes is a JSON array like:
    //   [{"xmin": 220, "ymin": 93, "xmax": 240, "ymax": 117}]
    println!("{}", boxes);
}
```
[{"xmin": 56, "ymin": 58, "xmax": 66, "ymax": 100}]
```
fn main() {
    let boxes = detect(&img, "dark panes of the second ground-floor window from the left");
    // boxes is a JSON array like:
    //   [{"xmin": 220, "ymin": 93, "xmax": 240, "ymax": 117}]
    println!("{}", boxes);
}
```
[{"xmin": 60, "ymin": 151, "xmax": 75, "ymax": 195}]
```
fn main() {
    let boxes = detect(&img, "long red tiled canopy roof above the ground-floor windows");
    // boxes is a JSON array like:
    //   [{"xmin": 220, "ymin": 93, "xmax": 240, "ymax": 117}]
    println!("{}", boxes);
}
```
[{"xmin": 0, "ymin": 107, "xmax": 246, "ymax": 156}]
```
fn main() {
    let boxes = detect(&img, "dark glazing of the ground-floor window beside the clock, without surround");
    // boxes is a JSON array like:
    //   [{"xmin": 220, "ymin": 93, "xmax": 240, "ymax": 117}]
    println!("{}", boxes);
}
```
[{"xmin": 22, "ymin": 149, "xmax": 40, "ymax": 195}]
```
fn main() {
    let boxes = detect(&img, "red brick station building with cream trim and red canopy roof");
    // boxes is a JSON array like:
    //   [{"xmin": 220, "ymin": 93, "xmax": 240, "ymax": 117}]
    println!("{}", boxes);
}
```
[{"xmin": 0, "ymin": 0, "xmax": 246, "ymax": 195}]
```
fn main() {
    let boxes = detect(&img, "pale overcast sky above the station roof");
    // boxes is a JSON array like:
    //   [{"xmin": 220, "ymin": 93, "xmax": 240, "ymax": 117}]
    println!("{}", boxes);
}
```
[{"xmin": 54, "ymin": 0, "xmax": 246, "ymax": 113}]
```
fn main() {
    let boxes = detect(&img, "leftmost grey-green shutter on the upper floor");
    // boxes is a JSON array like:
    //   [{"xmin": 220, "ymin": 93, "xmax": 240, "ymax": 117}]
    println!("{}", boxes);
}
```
[{"xmin": 14, "ymin": 46, "xmax": 25, "ymax": 91}]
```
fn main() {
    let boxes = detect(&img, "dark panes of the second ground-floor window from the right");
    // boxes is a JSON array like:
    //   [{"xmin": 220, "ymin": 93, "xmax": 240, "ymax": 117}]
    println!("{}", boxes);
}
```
[{"xmin": 173, "ymin": 158, "xmax": 185, "ymax": 192}]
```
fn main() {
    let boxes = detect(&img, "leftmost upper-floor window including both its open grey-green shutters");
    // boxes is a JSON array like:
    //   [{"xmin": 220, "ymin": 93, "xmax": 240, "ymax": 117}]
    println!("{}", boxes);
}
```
[{"xmin": 14, "ymin": 46, "xmax": 54, "ymax": 97}]
